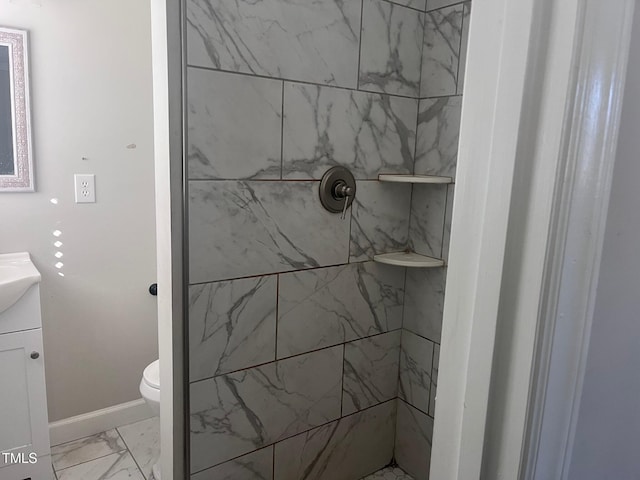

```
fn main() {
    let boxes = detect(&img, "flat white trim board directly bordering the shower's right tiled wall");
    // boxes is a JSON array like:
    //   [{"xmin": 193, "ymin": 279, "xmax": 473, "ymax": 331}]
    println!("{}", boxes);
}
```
[{"xmin": 430, "ymin": 0, "xmax": 536, "ymax": 480}]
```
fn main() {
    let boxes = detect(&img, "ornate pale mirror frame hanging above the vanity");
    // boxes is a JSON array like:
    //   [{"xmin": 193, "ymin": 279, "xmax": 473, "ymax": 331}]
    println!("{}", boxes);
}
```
[{"xmin": 0, "ymin": 27, "xmax": 35, "ymax": 192}]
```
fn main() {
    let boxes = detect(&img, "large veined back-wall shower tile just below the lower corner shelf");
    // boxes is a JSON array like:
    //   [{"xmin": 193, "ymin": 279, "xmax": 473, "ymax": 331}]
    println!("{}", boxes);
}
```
[{"xmin": 277, "ymin": 262, "xmax": 404, "ymax": 358}]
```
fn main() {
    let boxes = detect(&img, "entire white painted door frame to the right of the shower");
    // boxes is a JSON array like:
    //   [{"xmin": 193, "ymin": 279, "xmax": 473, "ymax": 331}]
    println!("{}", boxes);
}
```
[{"xmin": 431, "ymin": 0, "xmax": 634, "ymax": 480}]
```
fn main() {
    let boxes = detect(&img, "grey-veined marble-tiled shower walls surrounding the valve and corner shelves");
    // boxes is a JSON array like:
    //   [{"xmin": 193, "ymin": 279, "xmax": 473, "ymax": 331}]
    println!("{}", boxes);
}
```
[{"xmin": 186, "ymin": 0, "xmax": 467, "ymax": 480}]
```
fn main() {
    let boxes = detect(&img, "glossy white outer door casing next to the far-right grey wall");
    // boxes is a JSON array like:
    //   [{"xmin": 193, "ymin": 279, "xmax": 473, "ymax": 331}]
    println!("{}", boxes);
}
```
[{"xmin": 522, "ymin": 0, "xmax": 635, "ymax": 480}]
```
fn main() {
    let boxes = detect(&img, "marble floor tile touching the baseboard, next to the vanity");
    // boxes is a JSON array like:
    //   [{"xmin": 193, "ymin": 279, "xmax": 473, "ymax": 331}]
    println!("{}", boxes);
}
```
[{"xmin": 51, "ymin": 430, "xmax": 127, "ymax": 470}]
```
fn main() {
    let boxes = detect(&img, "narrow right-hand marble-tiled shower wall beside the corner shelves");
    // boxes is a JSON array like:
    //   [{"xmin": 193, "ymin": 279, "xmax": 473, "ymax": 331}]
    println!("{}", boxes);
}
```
[{"xmin": 394, "ymin": 0, "xmax": 471, "ymax": 480}]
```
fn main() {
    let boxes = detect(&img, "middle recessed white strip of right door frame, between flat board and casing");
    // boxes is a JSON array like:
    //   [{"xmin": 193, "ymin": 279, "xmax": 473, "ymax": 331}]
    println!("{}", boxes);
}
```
[{"xmin": 482, "ymin": 0, "xmax": 579, "ymax": 480}]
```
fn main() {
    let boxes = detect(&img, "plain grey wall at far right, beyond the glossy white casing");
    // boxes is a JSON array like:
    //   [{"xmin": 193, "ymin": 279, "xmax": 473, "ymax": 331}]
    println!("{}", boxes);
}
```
[{"xmin": 569, "ymin": 2, "xmax": 640, "ymax": 480}]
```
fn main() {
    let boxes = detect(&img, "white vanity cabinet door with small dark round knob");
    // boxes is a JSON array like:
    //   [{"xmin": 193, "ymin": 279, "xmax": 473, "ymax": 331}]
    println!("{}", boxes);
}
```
[{"xmin": 0, "ymin": 328, "xmax": 50, "ymax": 470}]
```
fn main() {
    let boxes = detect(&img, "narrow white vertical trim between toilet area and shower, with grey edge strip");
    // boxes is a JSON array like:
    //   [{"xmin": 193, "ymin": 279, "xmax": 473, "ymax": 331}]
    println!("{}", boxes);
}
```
[{"xmin": 151, "ymin": 0, "xmax": 189, "ymax": 480}]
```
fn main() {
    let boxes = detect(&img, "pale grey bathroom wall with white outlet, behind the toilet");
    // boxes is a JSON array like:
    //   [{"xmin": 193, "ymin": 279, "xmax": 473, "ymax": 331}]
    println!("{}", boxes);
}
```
[{"xmin": 0, "ymin": 0, "xmax": 158, "ymax": 421}]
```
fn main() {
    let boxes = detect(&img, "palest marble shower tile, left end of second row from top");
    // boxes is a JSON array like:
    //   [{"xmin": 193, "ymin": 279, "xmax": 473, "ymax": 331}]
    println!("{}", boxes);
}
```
[{"xmin": 187, "ymin": 68, "xmax": 282, "ymax": 179}]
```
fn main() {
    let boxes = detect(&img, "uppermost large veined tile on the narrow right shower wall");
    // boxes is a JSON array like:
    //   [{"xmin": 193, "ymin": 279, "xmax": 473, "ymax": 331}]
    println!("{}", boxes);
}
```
[{"xmin": 420, "ymin": 5, "xmax": 462, "ymax": 98}]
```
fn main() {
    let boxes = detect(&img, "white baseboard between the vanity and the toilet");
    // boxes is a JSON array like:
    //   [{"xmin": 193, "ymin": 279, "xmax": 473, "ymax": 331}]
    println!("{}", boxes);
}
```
[{"xmin": 49, "ymin": 398, "xmax": 153, "ymax": 445}]
